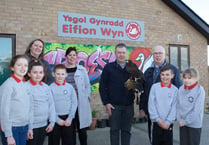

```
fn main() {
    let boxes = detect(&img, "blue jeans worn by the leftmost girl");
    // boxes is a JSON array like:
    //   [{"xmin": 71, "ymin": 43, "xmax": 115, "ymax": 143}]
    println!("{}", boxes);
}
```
[{"xmin": 1, "ymin": 125, "xmax": 28, "ymax": 145}]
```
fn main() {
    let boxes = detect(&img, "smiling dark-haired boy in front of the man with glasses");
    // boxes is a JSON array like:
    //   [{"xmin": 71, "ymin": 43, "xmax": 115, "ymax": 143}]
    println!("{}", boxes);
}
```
[{"xmin": 148, "ymin": 65, "xmax": 178, "ymax": 145}]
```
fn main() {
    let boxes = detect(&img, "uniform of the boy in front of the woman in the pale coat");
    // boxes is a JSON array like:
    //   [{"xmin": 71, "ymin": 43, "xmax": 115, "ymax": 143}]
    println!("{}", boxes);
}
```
[{"xmin": 49, "ymin": 81, "xmax": 77, "ymax": 145}]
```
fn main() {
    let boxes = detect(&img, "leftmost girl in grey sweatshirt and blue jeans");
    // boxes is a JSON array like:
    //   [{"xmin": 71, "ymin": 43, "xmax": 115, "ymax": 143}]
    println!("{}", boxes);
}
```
[{"xmin": 1, "ymin": 55, "xmax": 33, "ymax": 145}]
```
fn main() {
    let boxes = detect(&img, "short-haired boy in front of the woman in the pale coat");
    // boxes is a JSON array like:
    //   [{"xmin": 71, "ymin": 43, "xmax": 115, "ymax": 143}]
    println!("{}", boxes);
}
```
[{"xmin": 49, "ymin": 64, "xmax": 77, "ymax": 145}]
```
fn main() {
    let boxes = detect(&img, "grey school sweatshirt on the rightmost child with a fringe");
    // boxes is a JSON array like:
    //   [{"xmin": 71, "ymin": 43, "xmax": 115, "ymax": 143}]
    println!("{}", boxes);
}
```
[{"xmin": 177, "ymin": 85, "xmax": 205, "ymax": 128}]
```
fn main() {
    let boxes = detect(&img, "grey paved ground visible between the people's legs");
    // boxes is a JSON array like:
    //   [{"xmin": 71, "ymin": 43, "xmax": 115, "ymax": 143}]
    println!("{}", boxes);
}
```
[{"xmin": 0, "ymin": 114, "xmax": 209, "ymax": 145}]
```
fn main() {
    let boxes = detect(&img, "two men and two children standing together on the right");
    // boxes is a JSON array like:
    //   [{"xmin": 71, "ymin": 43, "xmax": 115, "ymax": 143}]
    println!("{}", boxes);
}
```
[{"xmin": 99, "ymin": 43, "xmax": 205, "ymax": 145}]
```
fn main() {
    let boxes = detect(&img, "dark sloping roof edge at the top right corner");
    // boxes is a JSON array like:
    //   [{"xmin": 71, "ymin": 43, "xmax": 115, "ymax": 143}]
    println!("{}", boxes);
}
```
[{"xmin": 162, "ymin": 0, "xmax": 209, "ymax": 44}]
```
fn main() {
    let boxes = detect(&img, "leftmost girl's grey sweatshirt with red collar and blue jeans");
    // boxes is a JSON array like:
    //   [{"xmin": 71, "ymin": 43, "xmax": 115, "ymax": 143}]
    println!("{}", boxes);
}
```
[{"xmin": 1, "ymin": 74, "xmax": 33, "ymax": 145}]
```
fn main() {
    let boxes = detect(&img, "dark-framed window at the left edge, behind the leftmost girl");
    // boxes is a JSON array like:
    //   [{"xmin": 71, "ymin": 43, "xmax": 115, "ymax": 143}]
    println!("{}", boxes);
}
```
[{"xmin": 0, "ymin": 33, "xmax": 16, "ymax": 85}]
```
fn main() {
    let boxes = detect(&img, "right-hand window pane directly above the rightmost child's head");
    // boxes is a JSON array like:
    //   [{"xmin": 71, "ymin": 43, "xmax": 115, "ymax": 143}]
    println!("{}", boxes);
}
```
[{"xmin": 181, "ymin": 47, "xmax": 189, "ymax": 71}]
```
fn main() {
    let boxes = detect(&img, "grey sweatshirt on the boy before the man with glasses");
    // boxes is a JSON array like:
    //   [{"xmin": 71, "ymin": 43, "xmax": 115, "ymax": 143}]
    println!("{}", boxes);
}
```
[{"xmin": 148, "ymin": 82, "xmax": 178, "ymax": 125}]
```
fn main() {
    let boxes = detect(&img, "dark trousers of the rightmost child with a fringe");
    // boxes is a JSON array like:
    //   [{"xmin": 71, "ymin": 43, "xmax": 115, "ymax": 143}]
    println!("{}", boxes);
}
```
[{"xmin": 180, "ymin": 126, "xmax": 201, "ymax": 145}]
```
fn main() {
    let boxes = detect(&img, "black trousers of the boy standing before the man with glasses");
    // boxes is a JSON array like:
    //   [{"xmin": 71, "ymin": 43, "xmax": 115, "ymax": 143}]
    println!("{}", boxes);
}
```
[{"xmin": 151, "ymin": 122, "xmax": 173, "ymax": 145}]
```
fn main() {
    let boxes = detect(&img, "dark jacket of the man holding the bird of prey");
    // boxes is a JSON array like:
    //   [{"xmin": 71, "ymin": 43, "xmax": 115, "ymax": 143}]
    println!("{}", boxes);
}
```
[{"xmin": 99, "ymin": 61, "xmax": 134, "ymax": 106}]
